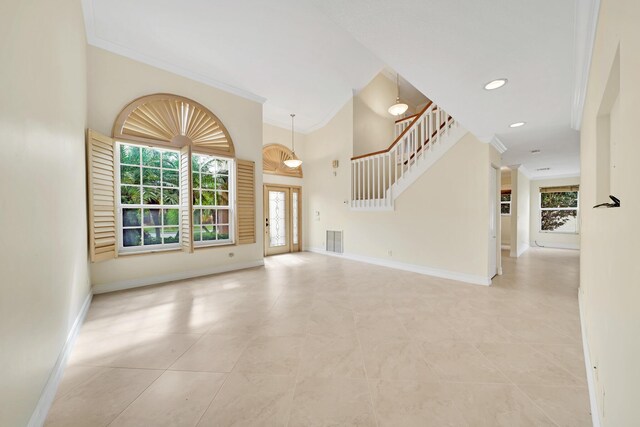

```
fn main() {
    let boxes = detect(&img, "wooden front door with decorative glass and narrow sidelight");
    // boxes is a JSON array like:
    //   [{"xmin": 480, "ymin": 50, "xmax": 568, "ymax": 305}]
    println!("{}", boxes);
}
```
[{"xmin": 264, "ymin": 185, "xmax": 300, "ymax": 256}]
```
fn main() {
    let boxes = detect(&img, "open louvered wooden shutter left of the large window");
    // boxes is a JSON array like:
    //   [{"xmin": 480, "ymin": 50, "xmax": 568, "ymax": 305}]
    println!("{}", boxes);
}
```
[{"xmin": 87, "ymin": 129, "xmax": 118, "ymax": 262}]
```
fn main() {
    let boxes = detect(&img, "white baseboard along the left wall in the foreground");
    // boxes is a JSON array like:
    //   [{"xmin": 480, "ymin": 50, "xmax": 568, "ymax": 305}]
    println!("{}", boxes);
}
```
[{"xmin": 27, "ymin": 293, "xmax": 93, "ymax": 427}]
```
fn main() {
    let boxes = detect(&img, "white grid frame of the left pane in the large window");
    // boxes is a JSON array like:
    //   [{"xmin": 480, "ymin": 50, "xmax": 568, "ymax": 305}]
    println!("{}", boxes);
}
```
[{"xmin": 114, "ymin": 140, "xmax": 182, "ymax": 255}]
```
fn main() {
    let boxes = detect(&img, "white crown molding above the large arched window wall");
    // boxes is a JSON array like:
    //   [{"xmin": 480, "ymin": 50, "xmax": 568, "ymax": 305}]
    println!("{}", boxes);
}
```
[{"xmin": 82, "ymin": 0, "xmax": 267, "ymax": 104}]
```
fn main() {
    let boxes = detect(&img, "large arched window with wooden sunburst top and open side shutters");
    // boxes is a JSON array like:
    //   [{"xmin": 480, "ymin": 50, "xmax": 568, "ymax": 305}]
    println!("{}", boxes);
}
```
[{"xmin": 88, "ymin": 94, "xmax": 256, "ymax": 260}]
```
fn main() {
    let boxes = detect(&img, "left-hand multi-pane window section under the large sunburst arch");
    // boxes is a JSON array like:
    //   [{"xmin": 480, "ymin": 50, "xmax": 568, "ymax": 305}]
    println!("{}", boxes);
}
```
[{"xmin": 118, "ymin": 143, "xmax": 180, "ymax": 250}]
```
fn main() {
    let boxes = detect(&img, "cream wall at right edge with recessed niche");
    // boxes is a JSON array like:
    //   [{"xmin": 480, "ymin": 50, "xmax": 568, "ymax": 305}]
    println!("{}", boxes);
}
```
[{"xmin": 580, "ymin": 0, "xmax": 640, "ymax": 427}]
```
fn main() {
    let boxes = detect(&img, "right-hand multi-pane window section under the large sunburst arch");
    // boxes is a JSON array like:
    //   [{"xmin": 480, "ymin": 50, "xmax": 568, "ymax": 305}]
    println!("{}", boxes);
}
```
[{"xmin": 191, "ymin": 154, "xmax": 233, "ymax": 245}]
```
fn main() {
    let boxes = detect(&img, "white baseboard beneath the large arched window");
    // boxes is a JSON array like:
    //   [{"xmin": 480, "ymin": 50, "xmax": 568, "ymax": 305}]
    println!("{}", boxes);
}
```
[{"xmin": 92, "ymin": 259, "xmax": 264, "ymax": 294}]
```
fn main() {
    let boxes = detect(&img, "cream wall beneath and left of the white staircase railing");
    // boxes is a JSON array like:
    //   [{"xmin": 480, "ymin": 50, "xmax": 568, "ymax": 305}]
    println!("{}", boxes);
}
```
[{"xmin": 305, "ymin": 98, "xmax": 500, "ymax": 279}]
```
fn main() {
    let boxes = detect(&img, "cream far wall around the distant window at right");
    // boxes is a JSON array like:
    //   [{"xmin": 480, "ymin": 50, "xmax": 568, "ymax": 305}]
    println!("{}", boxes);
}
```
[{"xmin": 530, "ymin": 177, "xmax": 583, "ymax": 249}]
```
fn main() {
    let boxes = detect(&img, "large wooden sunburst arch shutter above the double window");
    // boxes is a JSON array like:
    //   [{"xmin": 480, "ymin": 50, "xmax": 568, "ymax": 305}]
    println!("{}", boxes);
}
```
[{"xmin": 113, "ymin": 93, "xmax": 235, "ymax": 157}]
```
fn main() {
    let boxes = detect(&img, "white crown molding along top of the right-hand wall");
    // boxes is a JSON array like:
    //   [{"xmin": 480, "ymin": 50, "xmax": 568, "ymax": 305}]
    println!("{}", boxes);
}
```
[{"xmin": 571, "ymin": 0, "xmax": 600, "ymax": 130}]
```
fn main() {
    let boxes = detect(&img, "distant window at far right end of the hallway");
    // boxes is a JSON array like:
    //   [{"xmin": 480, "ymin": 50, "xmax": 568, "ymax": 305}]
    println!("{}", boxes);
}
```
[{"xmin": 540, "ymin": 187, "xmax": 579, "ymax": 233}]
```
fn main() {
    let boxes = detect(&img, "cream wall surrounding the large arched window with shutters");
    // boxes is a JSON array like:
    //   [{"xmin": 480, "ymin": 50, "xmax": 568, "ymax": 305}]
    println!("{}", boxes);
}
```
[{"xmin": 88, "ymin": 47, "xmax": 263, "ymax": 290}]
